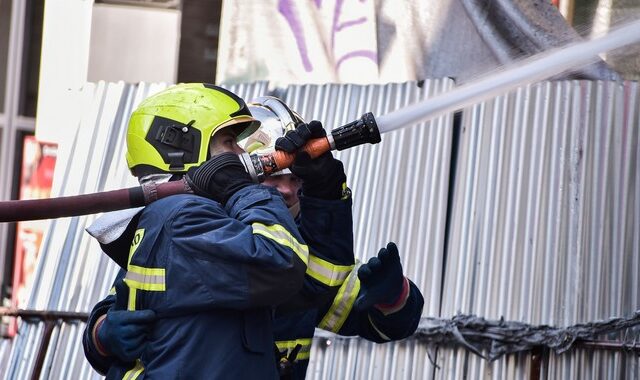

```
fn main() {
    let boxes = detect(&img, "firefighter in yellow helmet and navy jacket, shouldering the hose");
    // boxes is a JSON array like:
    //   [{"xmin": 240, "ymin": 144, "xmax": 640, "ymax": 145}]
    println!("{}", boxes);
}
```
[{"xmin": 84, "ymin": 83, "xmax": 308, "ymax": 379}]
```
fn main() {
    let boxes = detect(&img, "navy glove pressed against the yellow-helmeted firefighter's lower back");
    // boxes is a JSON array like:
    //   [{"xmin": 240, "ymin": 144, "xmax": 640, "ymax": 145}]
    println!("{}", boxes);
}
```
[{"xmin": 95, "ymin": 308, "xmax": 156, "ymax": 362}]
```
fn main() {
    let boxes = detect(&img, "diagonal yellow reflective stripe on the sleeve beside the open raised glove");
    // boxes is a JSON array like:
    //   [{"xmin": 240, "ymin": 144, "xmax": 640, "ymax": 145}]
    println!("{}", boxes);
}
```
[{"xmin": 318, "ymin": 263, "xmax": 360, "ymax": 333}]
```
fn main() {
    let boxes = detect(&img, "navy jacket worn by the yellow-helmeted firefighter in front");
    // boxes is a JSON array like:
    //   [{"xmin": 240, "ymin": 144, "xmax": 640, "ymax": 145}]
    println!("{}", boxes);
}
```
[{"xmin": 84, "ymin": 185, "xmax": 308, "ymax": 379}]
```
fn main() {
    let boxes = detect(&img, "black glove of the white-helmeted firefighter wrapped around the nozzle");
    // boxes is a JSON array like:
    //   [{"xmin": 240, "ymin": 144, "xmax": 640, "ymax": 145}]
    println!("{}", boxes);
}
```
[{"xmin": 275, "ymin": 120, "xmax": 348, "ymax": 200}]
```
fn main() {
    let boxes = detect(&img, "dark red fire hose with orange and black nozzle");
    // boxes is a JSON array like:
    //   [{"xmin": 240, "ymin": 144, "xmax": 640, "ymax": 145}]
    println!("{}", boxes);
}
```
[{"xmin": 0, "ymin": 112, "xmax": 381, "ymax": 222}]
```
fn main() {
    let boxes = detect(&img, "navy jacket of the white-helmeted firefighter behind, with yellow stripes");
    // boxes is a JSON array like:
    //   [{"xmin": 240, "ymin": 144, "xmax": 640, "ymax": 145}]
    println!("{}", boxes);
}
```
[{"xmin": 84, "ymin": 193, "xmax": 424, "ymax": 379}]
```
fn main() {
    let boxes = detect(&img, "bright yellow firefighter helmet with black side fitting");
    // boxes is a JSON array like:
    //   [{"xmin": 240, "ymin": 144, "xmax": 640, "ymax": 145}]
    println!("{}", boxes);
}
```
[{"xmin": 127, "ymin": 83, "xmax": 260, "ymax": 177}]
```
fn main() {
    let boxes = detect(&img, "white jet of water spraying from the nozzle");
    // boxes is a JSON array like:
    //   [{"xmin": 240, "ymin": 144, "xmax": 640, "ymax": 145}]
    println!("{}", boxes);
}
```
[{"xmin": 376, "ymin": 20, "xmax": 640, "ymax": 133}]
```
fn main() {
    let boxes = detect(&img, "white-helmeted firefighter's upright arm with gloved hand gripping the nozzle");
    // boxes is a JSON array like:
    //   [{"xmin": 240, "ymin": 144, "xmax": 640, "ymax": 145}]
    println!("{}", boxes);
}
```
[{"xmin": 275, "ymin": 126, "xmax": 354, "ymax": 308}]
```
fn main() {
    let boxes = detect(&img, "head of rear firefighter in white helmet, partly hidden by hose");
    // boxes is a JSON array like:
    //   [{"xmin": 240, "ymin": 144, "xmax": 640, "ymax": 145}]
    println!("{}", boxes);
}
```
[{"xmin": 240, "ymin": 96, "xmax": 304, "ymax": 212}]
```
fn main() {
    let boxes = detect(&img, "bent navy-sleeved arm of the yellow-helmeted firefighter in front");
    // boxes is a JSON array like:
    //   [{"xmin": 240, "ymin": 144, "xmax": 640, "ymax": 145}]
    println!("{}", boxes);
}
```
[{"xmin": 168, "ymin": 184, "xmax": 309, "ymax": 309}]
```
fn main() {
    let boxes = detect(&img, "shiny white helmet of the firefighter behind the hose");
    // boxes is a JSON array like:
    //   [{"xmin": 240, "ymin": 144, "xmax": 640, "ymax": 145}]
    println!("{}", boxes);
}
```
[{"xmin": 239, "ymin": 96, "xmax": 304, "ymax": 176}]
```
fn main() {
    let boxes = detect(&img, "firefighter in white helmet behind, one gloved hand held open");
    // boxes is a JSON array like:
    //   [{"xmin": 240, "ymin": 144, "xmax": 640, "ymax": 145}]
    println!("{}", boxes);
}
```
[{"xmin": 85, "ymin": 97, "xmax": 424, "ymax": 378}]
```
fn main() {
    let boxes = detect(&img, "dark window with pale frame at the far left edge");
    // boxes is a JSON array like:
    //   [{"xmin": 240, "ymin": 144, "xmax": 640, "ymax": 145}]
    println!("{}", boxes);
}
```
[{"xmin": 0, "ymin": 0, "xmax": 45, "ymax": 303}]
